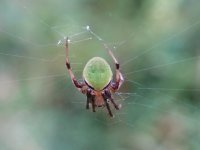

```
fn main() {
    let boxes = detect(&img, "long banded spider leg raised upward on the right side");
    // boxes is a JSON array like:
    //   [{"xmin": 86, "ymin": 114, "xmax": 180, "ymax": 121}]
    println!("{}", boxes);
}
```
[{"xmin": 104, "ymin": 44, "xmax": 124, "ymax": 92}]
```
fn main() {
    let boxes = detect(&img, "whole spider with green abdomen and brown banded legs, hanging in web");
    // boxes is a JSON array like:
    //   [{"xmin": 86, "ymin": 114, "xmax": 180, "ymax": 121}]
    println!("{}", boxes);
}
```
[{"xmin": 65, "ymin": 38, "xmax": 124, "ymax": 117}]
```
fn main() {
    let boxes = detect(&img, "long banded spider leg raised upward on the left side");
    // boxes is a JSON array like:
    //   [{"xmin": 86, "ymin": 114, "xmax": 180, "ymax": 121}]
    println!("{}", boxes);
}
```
[{"xmin": 65, "ymin": 38, "xmax": 85, "ymax": 91}]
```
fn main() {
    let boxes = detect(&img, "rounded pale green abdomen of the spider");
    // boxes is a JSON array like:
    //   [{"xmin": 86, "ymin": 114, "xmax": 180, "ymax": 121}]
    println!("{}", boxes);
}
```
[{"xmin": 83, "ymin": 57, "xmax": 113, "ymax": 91}]
